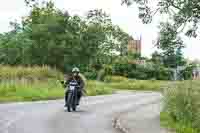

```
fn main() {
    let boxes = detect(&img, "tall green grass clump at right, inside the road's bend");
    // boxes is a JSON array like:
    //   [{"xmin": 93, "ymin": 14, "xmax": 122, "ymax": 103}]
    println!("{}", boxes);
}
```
[{"xmin": 162, "ymin": 81, "xmax": 200, "ymax": 133}]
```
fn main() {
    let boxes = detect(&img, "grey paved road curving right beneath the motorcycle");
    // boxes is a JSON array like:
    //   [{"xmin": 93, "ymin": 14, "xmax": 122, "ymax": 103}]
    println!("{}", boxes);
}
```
[{"xmin": 0, "ymin": 92, "xmax": 161, "ymax": 133}]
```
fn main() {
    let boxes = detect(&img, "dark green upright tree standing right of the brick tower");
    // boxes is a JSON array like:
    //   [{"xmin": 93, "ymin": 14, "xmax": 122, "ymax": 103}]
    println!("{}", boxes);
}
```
[{"xmin": 156, "ymin": 23, "xmax": 185, "ymax": 68}]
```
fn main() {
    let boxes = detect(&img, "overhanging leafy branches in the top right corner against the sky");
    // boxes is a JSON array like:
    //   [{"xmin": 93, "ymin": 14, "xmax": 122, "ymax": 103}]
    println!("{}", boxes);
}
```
[{"xmin": 122, "ymin": 0, "xmax": 200, "ymax": 37}]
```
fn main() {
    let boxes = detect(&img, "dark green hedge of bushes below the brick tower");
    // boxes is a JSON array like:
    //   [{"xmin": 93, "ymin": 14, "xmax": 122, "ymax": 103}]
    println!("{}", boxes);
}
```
[{"xmin": 112, "ymin": 57, "xmax": 172, "ymax": 80}]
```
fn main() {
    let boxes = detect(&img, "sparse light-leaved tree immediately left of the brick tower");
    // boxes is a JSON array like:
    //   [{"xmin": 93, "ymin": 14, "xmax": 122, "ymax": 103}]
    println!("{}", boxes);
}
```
[{"xmin": 87, "ymin": 9, "xmax": 129, "ymax": 67}]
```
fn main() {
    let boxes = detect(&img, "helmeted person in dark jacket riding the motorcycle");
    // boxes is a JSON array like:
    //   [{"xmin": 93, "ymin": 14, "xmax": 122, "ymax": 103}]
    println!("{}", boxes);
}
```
[{"xmin": 65, "ymin": 67, "xmax": 84, "ymax": 107}]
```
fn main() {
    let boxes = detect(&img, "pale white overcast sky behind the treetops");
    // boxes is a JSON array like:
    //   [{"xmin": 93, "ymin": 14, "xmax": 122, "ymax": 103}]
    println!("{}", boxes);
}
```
[{"xmin": 0, "ymin": 0, "xmax": 200, "ymax": 59}]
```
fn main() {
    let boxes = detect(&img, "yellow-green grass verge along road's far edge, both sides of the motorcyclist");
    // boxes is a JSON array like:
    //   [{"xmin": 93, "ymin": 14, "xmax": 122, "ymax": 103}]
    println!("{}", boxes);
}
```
[{"xmin": 0, "ymin": 65, "xmax": 169, "ymax": 102}]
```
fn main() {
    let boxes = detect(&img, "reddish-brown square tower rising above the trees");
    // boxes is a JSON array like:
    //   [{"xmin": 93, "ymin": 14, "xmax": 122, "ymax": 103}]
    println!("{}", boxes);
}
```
[{"xmin": 128, "ymin": 37, "xmax": 142, "ymax": 55}]
